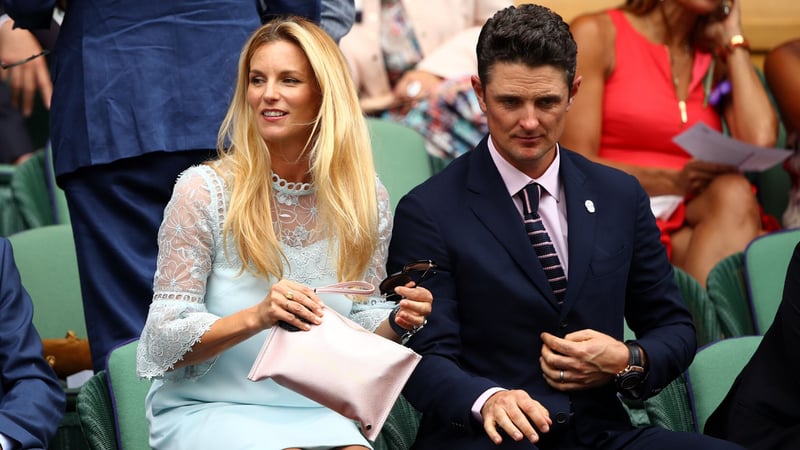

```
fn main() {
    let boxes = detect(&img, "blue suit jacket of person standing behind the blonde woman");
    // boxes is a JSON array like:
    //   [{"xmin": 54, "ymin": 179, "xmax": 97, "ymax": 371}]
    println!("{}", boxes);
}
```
[{"xmin": 3, "ymin": 0, "xmax": 261, "ymax": 176}]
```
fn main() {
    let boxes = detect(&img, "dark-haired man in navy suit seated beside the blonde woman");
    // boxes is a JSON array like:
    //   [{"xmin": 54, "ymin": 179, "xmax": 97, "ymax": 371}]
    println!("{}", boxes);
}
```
[{"xmin": 388, "ymin": 4, "xmax": 739, "ymax": 450}]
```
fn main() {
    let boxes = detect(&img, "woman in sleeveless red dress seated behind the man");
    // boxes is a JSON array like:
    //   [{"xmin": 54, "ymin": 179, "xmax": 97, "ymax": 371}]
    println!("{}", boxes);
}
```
[{"xmin": 561, "ymin": 0, "xmax": 779, "ymax": 285}]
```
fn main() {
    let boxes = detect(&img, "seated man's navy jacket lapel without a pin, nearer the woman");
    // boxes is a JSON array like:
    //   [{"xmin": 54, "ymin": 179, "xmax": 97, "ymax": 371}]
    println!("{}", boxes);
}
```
[{"xmin": 467, "ymin": 139, "xmax": 569, "ymax": 308}]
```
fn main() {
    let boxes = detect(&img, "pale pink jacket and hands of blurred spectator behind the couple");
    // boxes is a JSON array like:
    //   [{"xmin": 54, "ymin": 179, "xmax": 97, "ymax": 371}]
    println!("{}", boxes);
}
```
[{"xmin": 340, "ymin": 0, "xmax": 506, "ymax": 123}]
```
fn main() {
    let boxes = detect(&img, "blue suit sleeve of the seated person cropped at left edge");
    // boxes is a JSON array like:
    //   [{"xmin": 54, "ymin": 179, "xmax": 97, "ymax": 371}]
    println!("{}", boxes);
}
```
[{"xmin": 0, "ymin": 239, "xmax": 65, "ymax": 449}]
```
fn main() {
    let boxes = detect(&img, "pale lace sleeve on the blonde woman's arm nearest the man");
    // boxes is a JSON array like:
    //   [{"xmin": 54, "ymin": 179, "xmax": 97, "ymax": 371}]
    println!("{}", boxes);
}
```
[{"xmin": 350, "ymin": 180, "xmax": 395, "ymax": 331}]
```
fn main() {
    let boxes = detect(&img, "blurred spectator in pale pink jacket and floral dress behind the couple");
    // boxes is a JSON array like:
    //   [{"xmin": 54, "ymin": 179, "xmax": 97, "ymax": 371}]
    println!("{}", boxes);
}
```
[{"xmin": 340, "ymin": 0, "xmax": 513, "ymax": 159}]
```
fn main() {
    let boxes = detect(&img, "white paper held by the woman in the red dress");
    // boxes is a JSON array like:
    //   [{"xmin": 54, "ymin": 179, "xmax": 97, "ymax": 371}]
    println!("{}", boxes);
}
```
[{"xmin": 672, "ymin": 122, "xmax": 792, "ymax": 172}]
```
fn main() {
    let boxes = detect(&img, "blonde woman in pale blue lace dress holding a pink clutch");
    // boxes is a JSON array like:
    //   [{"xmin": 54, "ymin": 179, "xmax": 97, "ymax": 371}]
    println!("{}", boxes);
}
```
[{"xmin": 138, "ymin": 17, "xmax": 432, "ymax": 449}]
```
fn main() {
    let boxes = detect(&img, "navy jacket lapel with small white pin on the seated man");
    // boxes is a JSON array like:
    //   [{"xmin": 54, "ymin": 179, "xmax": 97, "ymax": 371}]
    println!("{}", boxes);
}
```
[{"xmin": 560, "ymin": 147, "xmax": 599, "ymax": 319}]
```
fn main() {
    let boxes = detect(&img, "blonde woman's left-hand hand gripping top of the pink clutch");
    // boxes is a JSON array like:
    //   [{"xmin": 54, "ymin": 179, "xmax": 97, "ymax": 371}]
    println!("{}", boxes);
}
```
[{"xmin": 257, "ymin": 279, "xmax": 325, "ymax": 330}]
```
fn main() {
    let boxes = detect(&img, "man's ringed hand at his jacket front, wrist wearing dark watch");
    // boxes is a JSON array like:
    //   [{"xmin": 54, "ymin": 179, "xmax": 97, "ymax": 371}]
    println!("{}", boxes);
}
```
[{"xmin": 539, "ymin": 330, "xmax": 630, "ymax": 391}]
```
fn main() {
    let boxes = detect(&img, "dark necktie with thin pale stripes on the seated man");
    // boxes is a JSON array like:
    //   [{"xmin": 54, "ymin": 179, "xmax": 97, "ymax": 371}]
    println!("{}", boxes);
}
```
[{"xmin": 518, "ymin": 183, "xmax": 567, "ymax": 304}]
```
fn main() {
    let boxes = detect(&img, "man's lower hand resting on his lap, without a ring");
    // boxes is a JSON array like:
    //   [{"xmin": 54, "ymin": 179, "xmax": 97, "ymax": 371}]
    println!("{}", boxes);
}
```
[{"xmin": 481, "ymin": 390, "xmax": 553, "ymax": 444}]
